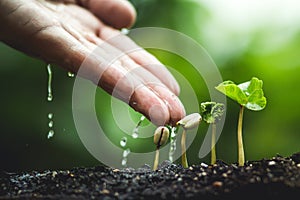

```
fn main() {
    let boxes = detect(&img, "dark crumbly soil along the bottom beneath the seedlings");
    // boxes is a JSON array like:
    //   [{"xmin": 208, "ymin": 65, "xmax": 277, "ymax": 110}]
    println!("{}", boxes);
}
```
[{"xmin": 0, "ymin": 153, "xmax": 300, "ymax": 200}]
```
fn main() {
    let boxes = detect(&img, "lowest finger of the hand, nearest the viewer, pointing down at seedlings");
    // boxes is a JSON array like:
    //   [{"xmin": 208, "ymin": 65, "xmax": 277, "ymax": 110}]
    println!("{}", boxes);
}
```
[{"xmin": 78, "ymin": 49, "xmax": 170, "ymax": 125}]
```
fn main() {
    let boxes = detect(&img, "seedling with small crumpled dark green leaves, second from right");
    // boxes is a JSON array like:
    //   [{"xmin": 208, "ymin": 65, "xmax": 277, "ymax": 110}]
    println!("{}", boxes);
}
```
[{"xmin": 200, "ymin": 102, "xmax": 225, "ymax": 165}]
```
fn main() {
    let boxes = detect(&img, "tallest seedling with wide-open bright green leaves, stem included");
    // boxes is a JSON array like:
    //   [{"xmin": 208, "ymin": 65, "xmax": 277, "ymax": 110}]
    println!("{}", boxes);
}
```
[{"xmin": 216, "ymin": 77, "xmax": 267, "ymax": 166}]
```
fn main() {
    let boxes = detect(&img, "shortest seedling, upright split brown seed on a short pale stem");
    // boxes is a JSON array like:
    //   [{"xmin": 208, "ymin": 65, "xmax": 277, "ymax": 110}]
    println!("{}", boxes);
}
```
[{"xmin": 153, "ymin": 126, "xmax": 170, "ymax": 170}]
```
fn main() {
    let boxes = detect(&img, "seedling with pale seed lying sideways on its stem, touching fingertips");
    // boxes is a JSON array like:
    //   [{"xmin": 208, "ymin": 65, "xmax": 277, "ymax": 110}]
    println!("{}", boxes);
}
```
[{"xmin": 176, "ymin": 113, "xmax": 202, "ymax": 168}]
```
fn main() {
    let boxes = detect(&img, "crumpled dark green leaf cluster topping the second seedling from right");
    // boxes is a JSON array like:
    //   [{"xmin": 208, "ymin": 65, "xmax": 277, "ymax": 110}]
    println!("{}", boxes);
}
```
[{"xmin": 200, "ymin": 102, "xmax": 225, "ymax": 124}]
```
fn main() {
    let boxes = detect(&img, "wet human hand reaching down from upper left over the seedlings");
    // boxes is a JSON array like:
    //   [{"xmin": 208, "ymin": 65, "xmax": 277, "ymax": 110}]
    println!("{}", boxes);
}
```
[{"xmin": 0, "ymin": 0, "xmax": 185, "ymax": 125}]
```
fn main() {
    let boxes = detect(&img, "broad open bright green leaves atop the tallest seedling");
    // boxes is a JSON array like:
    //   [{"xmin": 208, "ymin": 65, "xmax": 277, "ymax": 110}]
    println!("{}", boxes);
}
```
[{"xmin": 216, "ymin": 77, "xmax": 267, "ymax": 111}]
